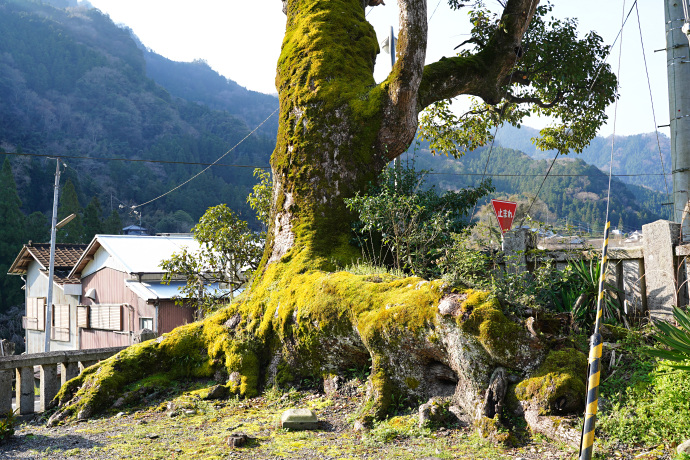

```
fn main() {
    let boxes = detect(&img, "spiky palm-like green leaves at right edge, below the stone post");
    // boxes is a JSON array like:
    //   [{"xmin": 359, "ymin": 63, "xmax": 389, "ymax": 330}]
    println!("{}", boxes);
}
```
[{"xmin": 647, "ymin": 307, "xmax": 690, "ymax": 370}]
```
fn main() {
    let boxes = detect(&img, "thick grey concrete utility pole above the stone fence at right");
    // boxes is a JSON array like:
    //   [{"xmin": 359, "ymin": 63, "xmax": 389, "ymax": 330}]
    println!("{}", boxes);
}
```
[{"xmin": 664, "ymin": 0, "xmax": 690, "ymax": 240}]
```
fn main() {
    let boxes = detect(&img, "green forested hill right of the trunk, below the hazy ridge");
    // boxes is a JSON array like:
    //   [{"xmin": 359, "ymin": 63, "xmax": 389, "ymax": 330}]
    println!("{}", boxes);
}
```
[{"xmin": 402, "ymin": 144, "xmax": 668, "ymax": 230}]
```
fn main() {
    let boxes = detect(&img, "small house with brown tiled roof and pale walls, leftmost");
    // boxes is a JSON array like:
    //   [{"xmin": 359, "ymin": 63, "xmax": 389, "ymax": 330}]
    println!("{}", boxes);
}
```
[{"xmin": 8, "ymin": 242, "xmax": 86, "ymax": 353}]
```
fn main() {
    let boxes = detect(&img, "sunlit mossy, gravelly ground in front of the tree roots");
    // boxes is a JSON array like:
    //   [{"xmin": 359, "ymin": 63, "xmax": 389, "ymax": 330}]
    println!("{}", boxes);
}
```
[{"xmin": 0, "ymin": 378, "xmax": 673, "ymax": 460}]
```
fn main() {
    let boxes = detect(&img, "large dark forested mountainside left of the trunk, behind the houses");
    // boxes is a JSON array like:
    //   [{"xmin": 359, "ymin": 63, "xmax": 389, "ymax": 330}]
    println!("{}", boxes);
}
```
[{"xmin": 0, "ymin": 0, "xmax": 277, "ymax": 231}]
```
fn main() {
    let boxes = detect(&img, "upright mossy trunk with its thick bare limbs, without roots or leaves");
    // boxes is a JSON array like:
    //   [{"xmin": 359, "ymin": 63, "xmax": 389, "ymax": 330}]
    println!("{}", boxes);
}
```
[{"xmin": 263, "ymin": 0, "xmax": 538, "ymax": 268}]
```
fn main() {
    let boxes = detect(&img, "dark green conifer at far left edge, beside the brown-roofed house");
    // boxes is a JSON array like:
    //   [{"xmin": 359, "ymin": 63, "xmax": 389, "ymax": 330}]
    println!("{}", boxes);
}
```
[{"xmin": 0, "ymin": 158, "xmax": 26, "ymax": 311}]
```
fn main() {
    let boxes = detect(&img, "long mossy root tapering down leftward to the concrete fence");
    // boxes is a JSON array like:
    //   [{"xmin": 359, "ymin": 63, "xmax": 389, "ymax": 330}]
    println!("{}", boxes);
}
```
[{"xmin": 48, "ymin": 308, "xmax": 261, "ymax": 425}]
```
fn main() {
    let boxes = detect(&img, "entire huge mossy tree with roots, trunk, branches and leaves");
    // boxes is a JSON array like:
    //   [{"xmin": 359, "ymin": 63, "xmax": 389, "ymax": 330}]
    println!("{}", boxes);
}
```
[{"xmin": 51, "ymin": 0, "xmax": 615, "ymax": 440}]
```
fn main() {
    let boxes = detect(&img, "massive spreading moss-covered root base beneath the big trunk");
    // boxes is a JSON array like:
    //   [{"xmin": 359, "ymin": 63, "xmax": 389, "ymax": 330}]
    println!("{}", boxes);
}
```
[{"xmin": 49, "ymin": 252, "xmax": 586, "ymax": 446}]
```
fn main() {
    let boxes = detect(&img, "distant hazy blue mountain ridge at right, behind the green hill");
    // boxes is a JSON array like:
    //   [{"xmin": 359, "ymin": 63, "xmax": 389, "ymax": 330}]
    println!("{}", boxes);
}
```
[{"xmin": 496, "ymin": 125, "xmax": 673, "ymax": 194}]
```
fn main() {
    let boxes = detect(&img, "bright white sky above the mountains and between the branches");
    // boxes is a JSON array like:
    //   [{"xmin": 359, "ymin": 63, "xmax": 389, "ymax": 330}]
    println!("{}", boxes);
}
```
[{"xmin": 90, "ymin": 0, "xmax": 669, "ymax": 136}]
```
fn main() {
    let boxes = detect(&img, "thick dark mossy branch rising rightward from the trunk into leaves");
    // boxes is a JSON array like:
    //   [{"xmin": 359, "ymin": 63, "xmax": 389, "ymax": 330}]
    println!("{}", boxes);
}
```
[{"xmin": 417, "ymin": 0, "xmax": 539, "ymax": 111}]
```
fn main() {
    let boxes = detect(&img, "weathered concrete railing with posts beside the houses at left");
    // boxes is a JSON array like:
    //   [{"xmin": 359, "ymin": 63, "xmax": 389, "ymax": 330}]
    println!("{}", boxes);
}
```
[{"xmin": 0, "ymin": 347, "xmax": 126, "ymax": 415}]
